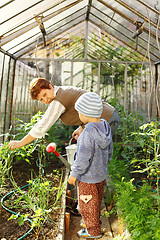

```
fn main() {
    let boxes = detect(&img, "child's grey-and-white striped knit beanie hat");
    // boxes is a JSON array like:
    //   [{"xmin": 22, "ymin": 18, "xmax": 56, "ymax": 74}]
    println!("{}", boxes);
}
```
[{"xmin": 75, "ymin": 92, "xmax": 103, "ymax": 118}]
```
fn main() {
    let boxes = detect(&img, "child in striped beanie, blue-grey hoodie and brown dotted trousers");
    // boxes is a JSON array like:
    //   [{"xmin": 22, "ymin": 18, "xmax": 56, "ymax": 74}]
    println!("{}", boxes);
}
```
[{"xmin": 68, "ymin": 92, "xmax": 113, "ymax": 238}]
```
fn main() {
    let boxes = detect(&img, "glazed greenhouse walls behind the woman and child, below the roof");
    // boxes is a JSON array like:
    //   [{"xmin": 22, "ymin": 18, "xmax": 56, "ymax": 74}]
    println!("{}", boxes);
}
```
[{"xmin": 0, "ymin": 53, "xmax": 159, "ymax": 142}]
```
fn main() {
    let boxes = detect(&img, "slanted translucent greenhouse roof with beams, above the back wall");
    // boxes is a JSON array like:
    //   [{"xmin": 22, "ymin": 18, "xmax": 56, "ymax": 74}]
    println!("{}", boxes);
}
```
[{"xmin": 0, "ymin": 0, "xmax": 160, "ymax": 62}]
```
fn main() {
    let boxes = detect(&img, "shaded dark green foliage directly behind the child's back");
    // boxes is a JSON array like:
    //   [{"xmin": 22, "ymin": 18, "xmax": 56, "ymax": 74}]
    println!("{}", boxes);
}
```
[{"xmin": 108, "ymin": 111, "xmax": 143, "ymax": 182}]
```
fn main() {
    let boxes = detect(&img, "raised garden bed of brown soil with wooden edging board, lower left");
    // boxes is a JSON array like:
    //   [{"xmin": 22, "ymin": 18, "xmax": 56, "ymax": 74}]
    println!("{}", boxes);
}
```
[{"xmin": 0, "ymin": 157, "xmax": 65, "ymax": 240}]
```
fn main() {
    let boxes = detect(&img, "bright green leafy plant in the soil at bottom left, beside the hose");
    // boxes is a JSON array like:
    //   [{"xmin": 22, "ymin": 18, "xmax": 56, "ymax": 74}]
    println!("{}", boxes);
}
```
[{"xmin": 7, "ymin": 171, "xmax": 66, "ymax": 236}]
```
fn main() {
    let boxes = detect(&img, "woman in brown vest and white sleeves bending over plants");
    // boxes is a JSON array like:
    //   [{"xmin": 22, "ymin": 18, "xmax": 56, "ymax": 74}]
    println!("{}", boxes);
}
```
[{"xmin": 9, "ymin": 78, "xmax": 120, "ymax": 150}]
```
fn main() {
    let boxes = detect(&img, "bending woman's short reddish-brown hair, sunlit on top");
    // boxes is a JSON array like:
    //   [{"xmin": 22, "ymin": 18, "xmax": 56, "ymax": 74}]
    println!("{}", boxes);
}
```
[{"xmin": 29, "ymin": 78, "xmax": 51, "ymax": 100}]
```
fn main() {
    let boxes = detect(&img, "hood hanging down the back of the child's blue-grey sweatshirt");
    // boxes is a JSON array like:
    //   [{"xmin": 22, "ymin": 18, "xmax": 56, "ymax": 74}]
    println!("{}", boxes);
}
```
[{"xmin": 87, "ymin": 119, "xmax": 112, "ymax": 149}]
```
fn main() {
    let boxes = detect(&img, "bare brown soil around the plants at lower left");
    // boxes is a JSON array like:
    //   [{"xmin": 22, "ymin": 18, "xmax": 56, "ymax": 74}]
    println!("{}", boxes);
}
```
[{"xmin": 0, "ymin": 160, "xmax": 65, "ymax": 240}]
